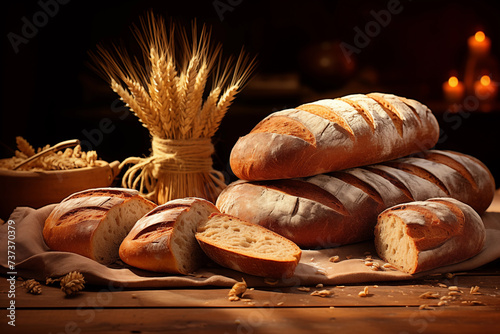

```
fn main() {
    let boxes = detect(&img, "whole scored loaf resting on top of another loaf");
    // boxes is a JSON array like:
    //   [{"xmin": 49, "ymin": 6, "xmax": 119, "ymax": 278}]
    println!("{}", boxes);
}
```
[{"xmin": 230, "ymin": 93, "xmax": 439, "ymax": 181}]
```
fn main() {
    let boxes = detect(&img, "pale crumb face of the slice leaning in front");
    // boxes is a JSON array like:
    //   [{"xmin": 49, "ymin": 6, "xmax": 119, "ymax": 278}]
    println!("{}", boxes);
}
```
[{"xmin": 198, "ymin": 215, "xmax": 296, "ymax": 261}]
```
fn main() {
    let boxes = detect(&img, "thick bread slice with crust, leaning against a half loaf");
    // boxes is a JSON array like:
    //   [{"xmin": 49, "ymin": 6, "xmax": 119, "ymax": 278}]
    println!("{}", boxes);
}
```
[{"xmin": 196, "ymin": 213, "xmax": 302, "ymax": 279}]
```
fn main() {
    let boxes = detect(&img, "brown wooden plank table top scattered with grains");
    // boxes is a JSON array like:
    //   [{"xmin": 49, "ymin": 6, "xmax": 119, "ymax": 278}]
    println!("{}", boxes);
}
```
[{"xmin": 0, "ymin": 190, "xmax": 500, "ymax": 334}]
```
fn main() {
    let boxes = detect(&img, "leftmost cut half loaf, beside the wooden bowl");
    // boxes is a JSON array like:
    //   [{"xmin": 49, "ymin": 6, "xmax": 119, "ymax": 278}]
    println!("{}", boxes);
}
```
[{"xmin": 43, "ymin": 188, "xmax": 156, "ymax": 264}]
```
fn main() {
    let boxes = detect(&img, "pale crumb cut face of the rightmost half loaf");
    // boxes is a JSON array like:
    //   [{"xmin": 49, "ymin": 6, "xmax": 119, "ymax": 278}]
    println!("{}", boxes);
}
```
[{"xmin": 375, "ymin": 215, "xmax": 418, "ymax": 273}]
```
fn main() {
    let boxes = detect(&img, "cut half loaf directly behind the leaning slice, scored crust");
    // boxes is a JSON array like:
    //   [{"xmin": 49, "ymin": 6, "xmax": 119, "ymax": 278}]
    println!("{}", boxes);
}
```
[{"xmin": 120, "ymin": 197, "xmax": 219, "ymax": 274}]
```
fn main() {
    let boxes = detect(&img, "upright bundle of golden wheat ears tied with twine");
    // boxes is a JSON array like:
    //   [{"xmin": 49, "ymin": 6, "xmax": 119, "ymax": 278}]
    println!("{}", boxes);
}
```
[{"xmin": 91, "ymin": 12, "xmax": 256, "ymax": 204}]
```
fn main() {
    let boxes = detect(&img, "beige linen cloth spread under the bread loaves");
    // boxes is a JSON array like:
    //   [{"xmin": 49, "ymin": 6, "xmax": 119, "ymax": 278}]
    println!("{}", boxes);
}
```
[{"xmin": 0, "ymin": 205, "xmax": 500, "ymax": 288}]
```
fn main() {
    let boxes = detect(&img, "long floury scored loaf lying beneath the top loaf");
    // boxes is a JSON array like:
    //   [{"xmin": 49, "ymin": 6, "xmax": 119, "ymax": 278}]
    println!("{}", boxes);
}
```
[{"xmin": 216, "ymin": 150, "xmax": 495, "ymax": 248}]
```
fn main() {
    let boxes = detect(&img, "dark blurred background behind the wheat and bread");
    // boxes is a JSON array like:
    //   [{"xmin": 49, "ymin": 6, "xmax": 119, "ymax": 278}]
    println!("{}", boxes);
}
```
[{"xmin": 0, "ymin": 0, "xmax": 500, "ymax": 184}]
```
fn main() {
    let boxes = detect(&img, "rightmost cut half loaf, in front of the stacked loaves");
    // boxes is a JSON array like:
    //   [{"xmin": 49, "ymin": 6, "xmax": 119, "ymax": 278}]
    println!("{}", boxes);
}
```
[{"xmin": 375, "ymin": 198, "xmax": 486, "ymax": 274}]
